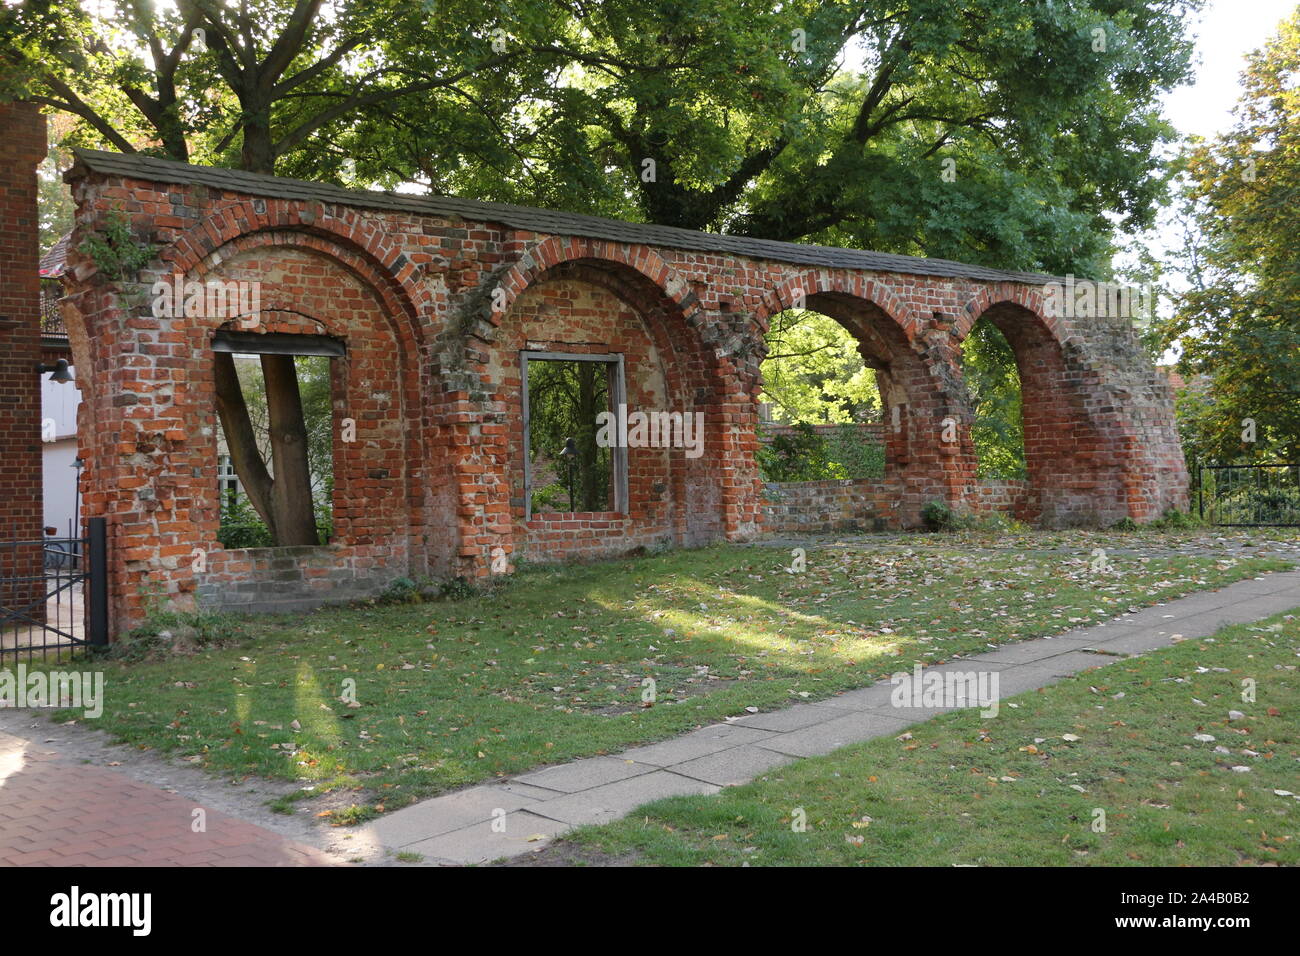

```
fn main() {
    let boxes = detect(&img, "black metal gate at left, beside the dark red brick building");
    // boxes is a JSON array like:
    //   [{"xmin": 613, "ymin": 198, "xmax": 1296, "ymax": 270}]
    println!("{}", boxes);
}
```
[{"xmin": 0, "ymin": 518, "xmax": 108, "ymax": 667}]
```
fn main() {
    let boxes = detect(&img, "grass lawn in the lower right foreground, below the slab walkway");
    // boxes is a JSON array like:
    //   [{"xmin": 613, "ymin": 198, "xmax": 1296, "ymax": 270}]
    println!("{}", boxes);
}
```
[{"xmin": 559, "ymin": 615, "xmax": 1300, "ymax": 866}]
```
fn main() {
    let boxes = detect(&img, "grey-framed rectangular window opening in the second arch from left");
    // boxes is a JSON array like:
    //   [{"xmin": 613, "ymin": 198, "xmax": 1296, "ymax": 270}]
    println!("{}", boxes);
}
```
[{"xmin": 521, "ymin": 351, "xmax": 627, "ymax": 518}]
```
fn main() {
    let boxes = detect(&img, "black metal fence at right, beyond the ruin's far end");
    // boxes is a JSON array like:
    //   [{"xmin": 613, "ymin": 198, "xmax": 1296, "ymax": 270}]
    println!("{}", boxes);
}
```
[{"xmin": 1196, "ymin": 462, "xmax": 1300, "ymax": 528}]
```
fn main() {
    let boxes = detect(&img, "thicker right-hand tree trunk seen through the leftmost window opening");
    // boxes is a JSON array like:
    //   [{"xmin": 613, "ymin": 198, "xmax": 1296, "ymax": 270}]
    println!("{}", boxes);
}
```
[{"xmin": 261, "ymin": 355, "xmax": 320, "ymax": 545}]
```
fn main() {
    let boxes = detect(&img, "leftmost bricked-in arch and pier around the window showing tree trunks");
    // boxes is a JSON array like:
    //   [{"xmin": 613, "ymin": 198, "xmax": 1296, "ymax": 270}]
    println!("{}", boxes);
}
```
[{"xmin": 66, "ymin": 228, "xmax": 452, "ymax": 629}]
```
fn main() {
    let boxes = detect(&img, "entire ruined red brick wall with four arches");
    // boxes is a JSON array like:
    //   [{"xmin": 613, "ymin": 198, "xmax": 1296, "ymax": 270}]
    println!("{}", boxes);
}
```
[{"xmin": 55, "ymin": 152, "xmax": 1186, "ymax": 630}]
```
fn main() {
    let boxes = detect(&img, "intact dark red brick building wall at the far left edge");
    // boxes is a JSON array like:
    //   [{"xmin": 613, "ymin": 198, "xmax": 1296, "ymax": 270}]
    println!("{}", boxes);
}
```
[{"xmin": 0, "ymin": 104, "xmax": 46, "ymax": 617}]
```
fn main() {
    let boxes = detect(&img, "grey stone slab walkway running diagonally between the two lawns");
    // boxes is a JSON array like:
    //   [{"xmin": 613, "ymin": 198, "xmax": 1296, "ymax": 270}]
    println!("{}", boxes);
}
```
[{"xmin": 371, "ymin": 571, "xmax": 1300, "ymax": 864}]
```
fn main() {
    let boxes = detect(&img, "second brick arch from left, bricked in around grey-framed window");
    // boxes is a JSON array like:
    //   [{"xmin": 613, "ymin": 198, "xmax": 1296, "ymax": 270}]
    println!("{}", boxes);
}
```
[{"xmin": 460, "ymin": 251, "xmax": 758, "ymax": 572}]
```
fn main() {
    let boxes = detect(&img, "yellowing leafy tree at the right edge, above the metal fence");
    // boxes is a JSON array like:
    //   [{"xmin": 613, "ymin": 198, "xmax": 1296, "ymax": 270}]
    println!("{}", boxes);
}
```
[{"xmin": 1165, "ymin": 10, "xmax": 1300, "ymax": 462}]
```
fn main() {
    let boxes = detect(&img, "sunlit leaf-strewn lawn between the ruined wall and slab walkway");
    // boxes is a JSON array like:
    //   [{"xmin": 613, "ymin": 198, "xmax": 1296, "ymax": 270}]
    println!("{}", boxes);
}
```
[{"xmin": 38, "ymin": 535, "xmax": 1290, "ymax": 822}]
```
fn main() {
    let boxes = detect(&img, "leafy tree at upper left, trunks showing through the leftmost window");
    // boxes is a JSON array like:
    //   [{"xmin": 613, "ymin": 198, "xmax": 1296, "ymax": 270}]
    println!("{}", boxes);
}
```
[{"xmin": 0, "ymin": 0, "xmax": 545, "ymax": 545}]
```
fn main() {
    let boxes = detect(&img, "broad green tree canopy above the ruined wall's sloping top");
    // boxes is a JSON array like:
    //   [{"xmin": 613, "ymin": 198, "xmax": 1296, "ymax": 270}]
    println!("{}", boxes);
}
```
[{"xmin": 0, "ymin": 0, "xmax": 1203, "ymax": 273}]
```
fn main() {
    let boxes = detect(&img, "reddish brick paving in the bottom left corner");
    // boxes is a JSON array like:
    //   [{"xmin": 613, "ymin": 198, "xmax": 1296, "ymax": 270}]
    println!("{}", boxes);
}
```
[{"xmin": 0, "ymin": 732, "xmax": 333, "ymax": 866}]
